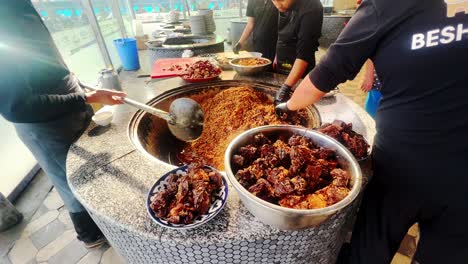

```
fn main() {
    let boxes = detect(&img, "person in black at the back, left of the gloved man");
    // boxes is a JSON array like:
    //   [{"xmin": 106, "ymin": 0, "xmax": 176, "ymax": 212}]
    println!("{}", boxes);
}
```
[{"xmin": 233, "ymin": 0, "xmax": 278, "ymax": 61}]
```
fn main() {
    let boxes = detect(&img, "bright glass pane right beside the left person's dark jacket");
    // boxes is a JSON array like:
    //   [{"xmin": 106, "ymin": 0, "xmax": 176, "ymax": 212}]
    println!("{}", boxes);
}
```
[{"xmin": 32, "ymin": 0, "xmax": 104, "ymax": 83}]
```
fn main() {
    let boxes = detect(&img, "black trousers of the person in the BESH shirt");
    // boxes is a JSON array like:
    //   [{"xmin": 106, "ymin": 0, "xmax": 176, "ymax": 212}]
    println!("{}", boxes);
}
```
[{"xmin": 345, "ymin": 145, "xmax": 468, "ymax": 264}]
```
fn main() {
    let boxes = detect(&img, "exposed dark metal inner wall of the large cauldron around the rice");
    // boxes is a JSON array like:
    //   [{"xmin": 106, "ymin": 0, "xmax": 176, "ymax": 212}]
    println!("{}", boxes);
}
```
[{"xmin": 128, "ymin": 81, "xmax": 321, "ymax": 166}]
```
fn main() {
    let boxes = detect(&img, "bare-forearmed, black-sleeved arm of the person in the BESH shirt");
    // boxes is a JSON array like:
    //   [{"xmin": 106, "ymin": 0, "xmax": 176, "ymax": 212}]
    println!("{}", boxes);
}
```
[{"xmin": 287, "ymin": 1, "xmax": 383, "ymax": 111}]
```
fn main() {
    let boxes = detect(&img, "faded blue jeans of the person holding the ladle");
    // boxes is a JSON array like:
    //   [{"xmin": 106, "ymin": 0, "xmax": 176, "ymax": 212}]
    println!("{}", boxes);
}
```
[{"xmin": 14, "ymin": 106, "xmax": 92, "ymax": 213}]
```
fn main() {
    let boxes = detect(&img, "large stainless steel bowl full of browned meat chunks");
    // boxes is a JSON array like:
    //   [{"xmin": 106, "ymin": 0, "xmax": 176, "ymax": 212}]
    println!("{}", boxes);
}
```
[{"xmin": 224, "ymin": 125, "xmax": 362, "ymax": 230}]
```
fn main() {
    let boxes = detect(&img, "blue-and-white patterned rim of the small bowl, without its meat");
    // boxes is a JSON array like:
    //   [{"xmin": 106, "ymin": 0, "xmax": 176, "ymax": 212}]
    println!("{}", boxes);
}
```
[{"xmin": 146, "ymin": 165, "xmax": 228, "ymax": 230}]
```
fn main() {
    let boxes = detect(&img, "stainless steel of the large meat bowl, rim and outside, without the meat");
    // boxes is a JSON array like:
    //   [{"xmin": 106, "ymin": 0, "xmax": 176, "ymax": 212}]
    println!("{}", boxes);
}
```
[{"xmin": 224, "ymin": 125, "xmax": 362, "ymax": 230}]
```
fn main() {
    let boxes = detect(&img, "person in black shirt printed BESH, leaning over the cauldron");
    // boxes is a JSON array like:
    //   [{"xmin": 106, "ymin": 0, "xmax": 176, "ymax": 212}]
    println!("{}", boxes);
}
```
[{"xmin": 277, "ymin": 0, "xmax": 468, "ymax": 263}]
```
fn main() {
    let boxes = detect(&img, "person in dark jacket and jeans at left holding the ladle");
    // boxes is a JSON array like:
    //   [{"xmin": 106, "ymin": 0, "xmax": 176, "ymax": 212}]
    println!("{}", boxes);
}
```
[{"xmin": 0, "ymin": 0, "xmax": 125, "ymax": 248}]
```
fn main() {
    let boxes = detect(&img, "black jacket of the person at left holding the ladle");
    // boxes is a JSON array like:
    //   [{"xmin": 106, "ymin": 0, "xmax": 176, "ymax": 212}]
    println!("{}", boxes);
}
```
[{"xmin": 0, "ymin": 0, "xmax": 86, "ymax": 123}]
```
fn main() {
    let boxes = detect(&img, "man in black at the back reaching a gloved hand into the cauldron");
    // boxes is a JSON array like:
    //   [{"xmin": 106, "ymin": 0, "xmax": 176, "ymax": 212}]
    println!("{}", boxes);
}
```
[{"xmin": 273, "ymin": 0, "xmax": 323, "ymax": 104}]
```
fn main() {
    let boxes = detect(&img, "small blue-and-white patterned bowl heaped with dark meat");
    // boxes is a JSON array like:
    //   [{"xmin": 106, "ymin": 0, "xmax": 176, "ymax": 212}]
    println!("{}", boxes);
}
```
[{"xmin": 146, "ymin": 164, "xmax": 228, "ymax": 230}]
